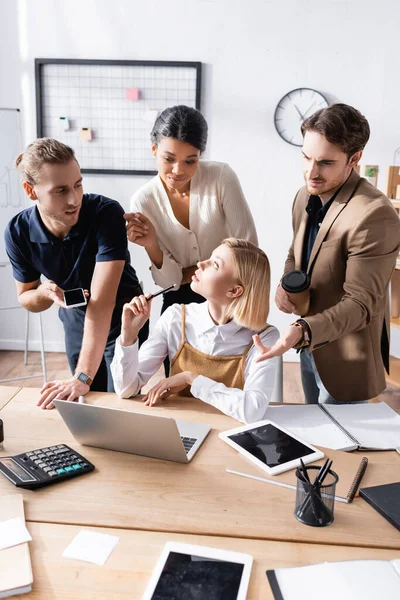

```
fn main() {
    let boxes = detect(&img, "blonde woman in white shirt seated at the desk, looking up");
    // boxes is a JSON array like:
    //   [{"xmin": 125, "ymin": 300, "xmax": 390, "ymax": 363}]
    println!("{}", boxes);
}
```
[{"xmin": 111, "ymin": 238, "xmax": 279, "ymax": 423}]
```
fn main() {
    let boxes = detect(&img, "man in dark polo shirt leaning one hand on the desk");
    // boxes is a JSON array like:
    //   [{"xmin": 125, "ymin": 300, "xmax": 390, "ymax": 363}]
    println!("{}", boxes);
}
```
[{"xmin": 5, "ymin": 138, "xmax": 147, "ymax": 408}]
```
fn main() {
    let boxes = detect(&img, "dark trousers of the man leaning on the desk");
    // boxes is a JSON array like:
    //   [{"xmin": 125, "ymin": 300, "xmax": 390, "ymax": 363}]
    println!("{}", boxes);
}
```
[{"xmin": 58, "ymin": 306, "xmax": 149, "ymax": 392}]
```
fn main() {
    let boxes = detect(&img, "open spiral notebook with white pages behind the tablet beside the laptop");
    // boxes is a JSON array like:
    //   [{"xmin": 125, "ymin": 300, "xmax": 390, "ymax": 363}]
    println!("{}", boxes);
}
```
[{"xmin": 266, "ymin": 402, "xmax": 400, "ymax": 451}]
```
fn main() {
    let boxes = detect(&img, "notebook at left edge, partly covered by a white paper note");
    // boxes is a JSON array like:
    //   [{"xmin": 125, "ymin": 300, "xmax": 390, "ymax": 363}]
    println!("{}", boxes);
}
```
[{"xmin": 0, "ymin": 494, "xmax": 33, "ymax": 598}]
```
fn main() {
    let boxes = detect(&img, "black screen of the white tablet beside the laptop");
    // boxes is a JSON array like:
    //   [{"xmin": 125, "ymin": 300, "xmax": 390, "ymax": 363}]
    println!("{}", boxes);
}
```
[{"xmin": 228, "ymin": 423, "xmax": 315, "ymax": 468}]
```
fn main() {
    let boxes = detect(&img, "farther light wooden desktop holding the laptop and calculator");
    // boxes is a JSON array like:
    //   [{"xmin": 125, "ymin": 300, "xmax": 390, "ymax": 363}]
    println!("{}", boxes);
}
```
[{"xmin": 0, "ymin": 388, "xmax": 400, "ymax": 549}]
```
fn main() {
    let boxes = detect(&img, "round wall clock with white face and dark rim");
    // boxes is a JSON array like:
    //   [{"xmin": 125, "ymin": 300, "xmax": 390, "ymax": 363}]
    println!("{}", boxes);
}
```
[{"xmin": 274, "ymin": 88, "xmax": 329, "ymax": 146}]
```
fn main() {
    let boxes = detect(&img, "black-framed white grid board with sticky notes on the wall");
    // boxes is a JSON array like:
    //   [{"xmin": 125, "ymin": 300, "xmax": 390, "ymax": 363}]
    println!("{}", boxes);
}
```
[{"xmin": 35, "ymin": 58, "xmax": 201, "ymax": 175}]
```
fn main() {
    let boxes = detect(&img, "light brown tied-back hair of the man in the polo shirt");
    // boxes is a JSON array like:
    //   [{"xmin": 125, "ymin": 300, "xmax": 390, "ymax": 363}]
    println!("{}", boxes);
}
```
[{"xmin": 15, "ymin": 138, "xmax": 76, "ymax": 185}]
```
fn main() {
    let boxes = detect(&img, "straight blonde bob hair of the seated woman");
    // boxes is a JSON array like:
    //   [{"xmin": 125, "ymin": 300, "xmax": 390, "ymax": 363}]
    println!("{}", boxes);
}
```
[{"xmin": 222, "ymin": 238, "xmax": 271, "ymax": 331}]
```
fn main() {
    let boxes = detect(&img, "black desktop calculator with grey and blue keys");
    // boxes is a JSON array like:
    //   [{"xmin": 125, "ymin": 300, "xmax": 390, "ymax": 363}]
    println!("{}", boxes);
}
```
[{"xmin": 0, "ymin": 444, "xmax": 94, "ymax": 490}]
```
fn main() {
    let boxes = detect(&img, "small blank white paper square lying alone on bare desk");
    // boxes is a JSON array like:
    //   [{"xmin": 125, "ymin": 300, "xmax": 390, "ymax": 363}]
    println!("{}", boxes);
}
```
[{"xmin": 63, "ymin": 529, "xmax": 119, "ymax": 565}]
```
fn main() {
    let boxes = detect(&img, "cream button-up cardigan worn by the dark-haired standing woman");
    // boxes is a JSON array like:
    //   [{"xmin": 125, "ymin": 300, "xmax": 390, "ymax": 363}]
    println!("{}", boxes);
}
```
[{"xmin": 130, "ymin": 161, "xmax": 258, "ymax": 287}]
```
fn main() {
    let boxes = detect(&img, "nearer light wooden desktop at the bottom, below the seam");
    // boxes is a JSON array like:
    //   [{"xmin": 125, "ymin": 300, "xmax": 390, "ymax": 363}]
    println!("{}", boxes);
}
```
[{"xmin": 24, "ymin": 523, "xmax": 400, "ymax": 600}]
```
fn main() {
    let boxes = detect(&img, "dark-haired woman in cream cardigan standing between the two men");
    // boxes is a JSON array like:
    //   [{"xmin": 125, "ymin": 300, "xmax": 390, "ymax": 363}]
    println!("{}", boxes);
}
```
[{"xmin": 125, "ymin": 106, "xmax": 257, "ymax": 312}]
